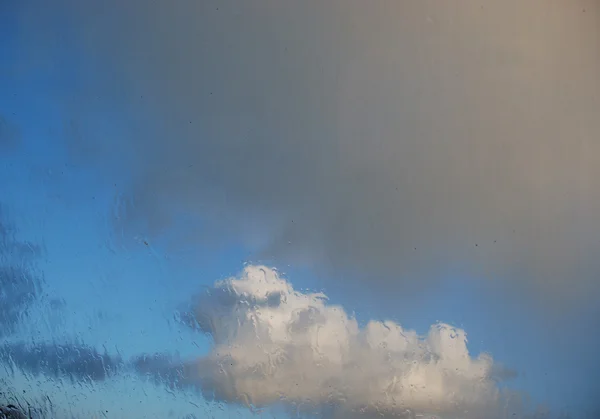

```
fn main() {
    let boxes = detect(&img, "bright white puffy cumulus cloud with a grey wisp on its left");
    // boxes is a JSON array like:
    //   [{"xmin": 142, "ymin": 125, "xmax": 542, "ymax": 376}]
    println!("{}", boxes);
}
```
[{"xmin": 136, "ymin": 266, "xmax": 516, "ymax": 418}]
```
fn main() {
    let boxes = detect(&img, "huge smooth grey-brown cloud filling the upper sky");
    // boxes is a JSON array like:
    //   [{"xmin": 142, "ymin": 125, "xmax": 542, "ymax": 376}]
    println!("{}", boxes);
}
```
[{"xmin": 10, "ymin": 0, "xmax": 600, "ymax": 307}]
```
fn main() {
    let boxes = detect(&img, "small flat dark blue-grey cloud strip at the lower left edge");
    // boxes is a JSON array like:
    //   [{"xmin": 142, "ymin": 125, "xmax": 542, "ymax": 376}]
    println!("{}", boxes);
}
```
[{"xmin": 0, "ymin": 342, "xmax": 123, "ymax": 381}]
